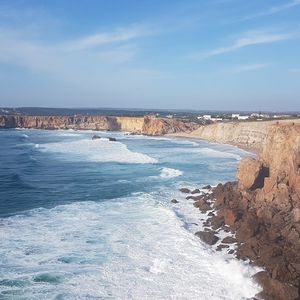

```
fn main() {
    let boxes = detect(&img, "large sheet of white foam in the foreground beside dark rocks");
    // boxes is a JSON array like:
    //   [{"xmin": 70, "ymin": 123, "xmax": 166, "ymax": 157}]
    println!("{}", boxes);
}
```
[{"xmin": 0, "ymin": 194, "xmax": 260, "ymax": 300}]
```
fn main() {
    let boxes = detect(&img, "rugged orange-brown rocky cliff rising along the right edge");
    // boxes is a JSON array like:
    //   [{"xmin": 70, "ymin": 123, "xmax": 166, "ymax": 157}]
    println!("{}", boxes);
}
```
[{"xmin": 212, "ymin": 124, "xmax": 300, "ymax": 300}]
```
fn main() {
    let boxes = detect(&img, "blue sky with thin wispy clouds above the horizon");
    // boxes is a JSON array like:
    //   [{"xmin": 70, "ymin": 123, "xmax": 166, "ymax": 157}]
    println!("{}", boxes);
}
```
[{"xmin": 0, "ymin": 0, "xmax": 300, "ymax": 111}]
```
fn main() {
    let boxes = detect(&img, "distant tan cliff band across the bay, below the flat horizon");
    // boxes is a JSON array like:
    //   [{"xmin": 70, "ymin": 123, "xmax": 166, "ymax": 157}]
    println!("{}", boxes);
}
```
[{"xmin": 0, "ymin": 116, "xmax": 199, "ymax": 135}]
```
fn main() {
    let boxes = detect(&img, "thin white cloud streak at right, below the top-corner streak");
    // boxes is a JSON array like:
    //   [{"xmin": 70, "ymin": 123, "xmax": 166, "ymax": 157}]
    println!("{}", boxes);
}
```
[{"xmin": 191, "ymin": 32, "xmax": 296, "ymax": 59}]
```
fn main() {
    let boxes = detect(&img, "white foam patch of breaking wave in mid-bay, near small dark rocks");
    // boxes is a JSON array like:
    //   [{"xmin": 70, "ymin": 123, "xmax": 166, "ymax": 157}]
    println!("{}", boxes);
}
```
[{"xmin": 40, "ymin": 139, "xmax": 157, "ymax": 164}]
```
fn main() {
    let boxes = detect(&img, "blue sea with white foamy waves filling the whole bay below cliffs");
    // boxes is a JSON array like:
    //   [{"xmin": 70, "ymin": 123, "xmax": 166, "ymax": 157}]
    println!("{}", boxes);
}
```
[{"xmin": 0, "ymin": 130, "xmax": 260, "ymax": 299}]
